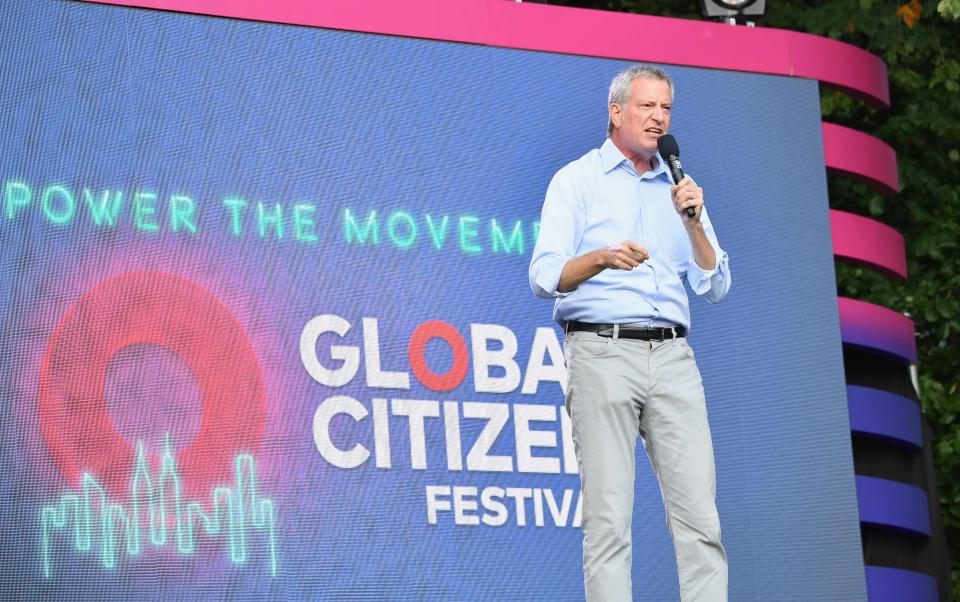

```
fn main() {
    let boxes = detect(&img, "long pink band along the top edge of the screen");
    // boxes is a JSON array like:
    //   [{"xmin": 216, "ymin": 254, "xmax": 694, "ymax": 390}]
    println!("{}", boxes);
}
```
[{"xmin": 81, "ymin": 0, "xmax": 890, "ymax": 106}]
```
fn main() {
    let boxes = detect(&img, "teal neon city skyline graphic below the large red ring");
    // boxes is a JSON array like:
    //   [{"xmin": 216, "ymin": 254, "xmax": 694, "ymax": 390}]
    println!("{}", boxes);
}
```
[{"xmin": 40, "ymin": 434, "xmax": 277, "ymax": 579}]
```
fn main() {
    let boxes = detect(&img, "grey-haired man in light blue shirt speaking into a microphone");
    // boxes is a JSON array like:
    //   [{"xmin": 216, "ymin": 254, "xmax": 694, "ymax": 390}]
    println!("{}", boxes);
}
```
[{"xmin": 530, "ymin": 65, "xmax": 730, "ymax": 602}]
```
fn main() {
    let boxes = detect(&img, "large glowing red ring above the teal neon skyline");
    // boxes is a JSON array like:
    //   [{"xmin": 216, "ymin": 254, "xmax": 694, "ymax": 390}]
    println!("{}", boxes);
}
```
[{"xmin": 39, "ymin": 272, "xmax": 266, "ymax": 496}]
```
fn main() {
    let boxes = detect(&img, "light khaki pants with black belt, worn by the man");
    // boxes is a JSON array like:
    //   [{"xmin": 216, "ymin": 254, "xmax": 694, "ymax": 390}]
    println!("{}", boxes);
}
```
[{"xmin": 564, "ymin": 332, "xmax": 727, "ymax": 602}]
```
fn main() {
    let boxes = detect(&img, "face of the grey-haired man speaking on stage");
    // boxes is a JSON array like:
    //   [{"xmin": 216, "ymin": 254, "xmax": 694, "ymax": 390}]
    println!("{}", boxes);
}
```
[{"xmin": 610, "ymin": 77, "xmax": 671, "ymax": 159}]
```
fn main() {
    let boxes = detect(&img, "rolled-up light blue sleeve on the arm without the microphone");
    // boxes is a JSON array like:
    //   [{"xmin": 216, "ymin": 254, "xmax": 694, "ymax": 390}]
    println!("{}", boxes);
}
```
[{"xmin": 528, "ymin": 166, "xmax": 586, "ymax": 299}]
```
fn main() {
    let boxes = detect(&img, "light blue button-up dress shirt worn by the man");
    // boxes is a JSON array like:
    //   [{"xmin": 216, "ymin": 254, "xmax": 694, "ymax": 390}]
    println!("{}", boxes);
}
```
[{"xmin": 529, "ymin": 138, "xmax": 730, "ymax": 328}]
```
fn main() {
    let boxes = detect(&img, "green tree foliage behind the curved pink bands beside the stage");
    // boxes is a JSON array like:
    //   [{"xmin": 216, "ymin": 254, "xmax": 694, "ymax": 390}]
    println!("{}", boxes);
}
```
[{"xmin": 560, "ymin": 0, "xmax": 960, "ymax": 600}]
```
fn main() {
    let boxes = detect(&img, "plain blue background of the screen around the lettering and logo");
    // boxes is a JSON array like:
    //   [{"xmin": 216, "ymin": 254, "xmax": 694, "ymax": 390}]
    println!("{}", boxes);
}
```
[{"xmin": 0, "ymin": 0, "xmax": 865, "ymax": 600}]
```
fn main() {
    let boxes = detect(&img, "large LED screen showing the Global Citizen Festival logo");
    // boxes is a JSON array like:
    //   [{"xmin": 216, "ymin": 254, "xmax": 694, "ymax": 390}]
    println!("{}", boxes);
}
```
[{"xmin": 0, "ymin": 0, "xmax": 864, "ymax": 600}]
